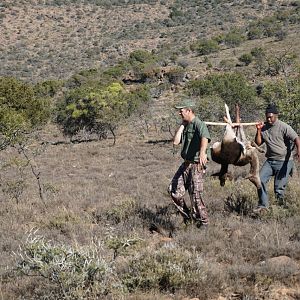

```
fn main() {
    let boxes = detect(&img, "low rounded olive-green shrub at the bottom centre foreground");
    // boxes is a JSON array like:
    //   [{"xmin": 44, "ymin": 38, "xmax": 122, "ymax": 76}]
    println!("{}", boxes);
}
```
[{"xmin": 121, "ymin": 246, "xmax": 224, "ymax": 299}]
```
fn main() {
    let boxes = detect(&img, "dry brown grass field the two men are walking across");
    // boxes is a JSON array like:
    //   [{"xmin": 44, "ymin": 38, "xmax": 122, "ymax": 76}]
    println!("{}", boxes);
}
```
[{"xmin": 1, "ymin": 123, "xmax": 300, "ymax": 299}]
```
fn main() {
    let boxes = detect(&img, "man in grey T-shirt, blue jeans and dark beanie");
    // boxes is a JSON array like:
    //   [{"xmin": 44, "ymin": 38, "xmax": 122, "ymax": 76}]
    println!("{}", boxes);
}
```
[{"xmin": 254, "ymin": 104, "xmax": 300, "ymax": 212}]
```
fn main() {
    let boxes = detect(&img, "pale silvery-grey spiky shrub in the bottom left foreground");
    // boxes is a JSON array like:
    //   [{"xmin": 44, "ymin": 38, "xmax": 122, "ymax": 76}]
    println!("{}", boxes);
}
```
[{"xmin": 16, "ymin": 231, "xmax": 116, "ymax": 299}]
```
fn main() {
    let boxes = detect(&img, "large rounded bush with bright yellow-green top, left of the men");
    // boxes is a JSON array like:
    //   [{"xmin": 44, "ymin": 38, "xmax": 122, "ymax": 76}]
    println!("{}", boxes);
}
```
[{"xmin": 56, "ymin": 82, "xmax": 149, "ymax": 142}]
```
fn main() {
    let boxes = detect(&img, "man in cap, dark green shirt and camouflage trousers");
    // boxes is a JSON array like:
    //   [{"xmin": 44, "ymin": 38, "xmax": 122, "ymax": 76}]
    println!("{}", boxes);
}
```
[{"xmin": 169, "ymin": 100, "xmax": 210, "ymax": 228}]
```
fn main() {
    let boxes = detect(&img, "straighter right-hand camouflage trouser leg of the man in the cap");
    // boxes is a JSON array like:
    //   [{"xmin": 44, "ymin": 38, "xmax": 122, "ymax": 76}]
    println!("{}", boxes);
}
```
[{"xmin": 189, "ymin": 164, "xmax": 208, "ymax": 225}]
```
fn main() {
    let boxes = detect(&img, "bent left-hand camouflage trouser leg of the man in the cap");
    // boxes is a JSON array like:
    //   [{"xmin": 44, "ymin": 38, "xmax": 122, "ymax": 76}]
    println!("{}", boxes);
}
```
[{"xmin": 168, "ymin": 164, "xmax": 190, "ymax": 218}]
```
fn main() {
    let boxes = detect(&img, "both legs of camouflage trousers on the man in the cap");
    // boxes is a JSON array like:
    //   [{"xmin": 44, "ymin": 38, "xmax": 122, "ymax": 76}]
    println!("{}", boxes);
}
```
[{"xmin": 168, "ymin": 162, "xmax": 208, "ymax": 225}]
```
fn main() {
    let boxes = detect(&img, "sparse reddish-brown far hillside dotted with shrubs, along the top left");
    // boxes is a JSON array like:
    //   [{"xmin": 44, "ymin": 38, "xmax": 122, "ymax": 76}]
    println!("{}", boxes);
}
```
[{"xmin": 0, "ymin": 0, "xmax": 298, "ymax": 81}]
